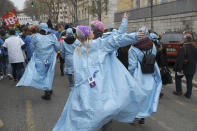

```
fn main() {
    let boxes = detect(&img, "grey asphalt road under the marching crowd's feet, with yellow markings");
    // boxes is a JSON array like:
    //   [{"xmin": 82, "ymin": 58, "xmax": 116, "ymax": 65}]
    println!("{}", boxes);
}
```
[{"xmin": 0, "ymin": 63, "xmax": 197, "ymax": 131}]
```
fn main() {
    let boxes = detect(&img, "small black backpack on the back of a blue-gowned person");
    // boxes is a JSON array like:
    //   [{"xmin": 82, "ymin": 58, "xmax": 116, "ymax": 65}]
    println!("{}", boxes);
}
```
[{"xmin": 140, "ymin": 50, "xmax": 156, "ymax": 74}]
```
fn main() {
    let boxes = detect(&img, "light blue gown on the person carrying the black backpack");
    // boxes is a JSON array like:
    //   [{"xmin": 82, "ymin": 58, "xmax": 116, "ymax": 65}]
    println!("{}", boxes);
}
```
[{"xmin": 128, "ymin": 45, "xmax": 162, "ymax": 118}]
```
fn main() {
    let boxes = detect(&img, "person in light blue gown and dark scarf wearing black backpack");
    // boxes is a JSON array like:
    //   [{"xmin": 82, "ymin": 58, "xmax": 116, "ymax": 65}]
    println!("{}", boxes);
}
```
[{"xmin": 128, "ymin": 33, "xmax": 162, "ymax": 124}]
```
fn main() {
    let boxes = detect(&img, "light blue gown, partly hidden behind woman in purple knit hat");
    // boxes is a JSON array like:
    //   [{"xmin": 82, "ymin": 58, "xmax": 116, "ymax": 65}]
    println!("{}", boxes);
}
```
[{"xmin": 61, "ymin": 39, "xmax": 80, "ymax": 74}]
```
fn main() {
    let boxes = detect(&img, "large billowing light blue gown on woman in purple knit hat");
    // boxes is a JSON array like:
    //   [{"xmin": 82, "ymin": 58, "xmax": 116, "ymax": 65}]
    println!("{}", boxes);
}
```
[{"xmin": 53, "ymin": 30, "xmax": 149, "ymax": 131}]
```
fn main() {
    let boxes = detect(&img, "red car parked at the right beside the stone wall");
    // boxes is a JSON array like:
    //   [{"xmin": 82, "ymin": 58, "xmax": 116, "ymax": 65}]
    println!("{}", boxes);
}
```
[{"xmin": 160, "ymin": 32, "xmax": 197, "ymax": 63}]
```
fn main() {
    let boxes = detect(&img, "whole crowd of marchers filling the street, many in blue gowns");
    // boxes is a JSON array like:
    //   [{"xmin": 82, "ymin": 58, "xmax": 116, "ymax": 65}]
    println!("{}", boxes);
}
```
[{"xmin": 0, "ymin": 13, "xmax": 197, "ymax": 131}]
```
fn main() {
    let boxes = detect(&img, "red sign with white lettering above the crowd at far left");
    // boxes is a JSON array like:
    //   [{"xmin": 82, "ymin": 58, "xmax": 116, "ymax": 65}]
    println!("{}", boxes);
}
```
[{"xmin": 2, "ymin": 9, "xmax": 19, "ymax": 27}]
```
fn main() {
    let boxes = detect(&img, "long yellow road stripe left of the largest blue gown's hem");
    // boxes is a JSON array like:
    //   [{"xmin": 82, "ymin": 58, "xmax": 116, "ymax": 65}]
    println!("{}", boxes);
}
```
[{"xmin": 26, "ymin": 100, "xmax": 35, "ymax": 131}]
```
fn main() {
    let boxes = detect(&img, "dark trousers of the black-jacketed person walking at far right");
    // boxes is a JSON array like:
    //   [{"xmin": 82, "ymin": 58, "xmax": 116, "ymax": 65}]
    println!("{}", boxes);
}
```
[{"xmin": 175, "ymin": 73, "xmax": 193, "ymax": 97}]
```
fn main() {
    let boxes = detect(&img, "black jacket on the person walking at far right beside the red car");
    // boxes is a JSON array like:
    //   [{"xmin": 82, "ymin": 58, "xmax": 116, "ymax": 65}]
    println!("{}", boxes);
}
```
[{"xmin": 174, "ymin": 43, "xmax": 197, "ymax": 75}]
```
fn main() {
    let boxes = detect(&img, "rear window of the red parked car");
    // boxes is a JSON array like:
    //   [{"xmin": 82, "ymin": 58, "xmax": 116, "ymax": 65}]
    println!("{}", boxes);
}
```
[{"xmin": 161, "ymin": 33, "xmax": 184, "ymax": 43}]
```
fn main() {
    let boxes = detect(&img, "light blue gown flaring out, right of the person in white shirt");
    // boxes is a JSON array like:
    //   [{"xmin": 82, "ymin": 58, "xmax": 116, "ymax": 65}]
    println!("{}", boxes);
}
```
[{"xmin": 17, "ymin": 34, "xmax": 60, "ymax": 90}]
